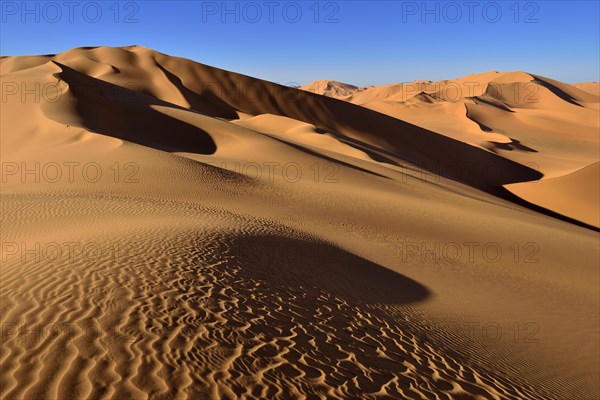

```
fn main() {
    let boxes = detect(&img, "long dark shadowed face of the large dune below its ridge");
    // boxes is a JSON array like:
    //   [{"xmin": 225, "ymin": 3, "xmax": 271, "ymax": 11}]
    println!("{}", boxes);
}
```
[{"xmin": 151, "ymin": 55, "xmax": 542, "ymax": 188}]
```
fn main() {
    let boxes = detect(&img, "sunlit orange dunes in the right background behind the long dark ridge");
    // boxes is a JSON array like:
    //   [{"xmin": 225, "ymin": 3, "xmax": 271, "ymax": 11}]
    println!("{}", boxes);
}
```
[{"xmin": 322, "ymin": 71, "xmax": 600, "ymax": 222}]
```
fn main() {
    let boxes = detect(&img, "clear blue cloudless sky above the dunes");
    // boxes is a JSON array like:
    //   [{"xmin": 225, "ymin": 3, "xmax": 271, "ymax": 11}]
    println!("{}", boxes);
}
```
[{"xmin": 0, "ymin": 0, "xmax": 600, "ymax": 85}]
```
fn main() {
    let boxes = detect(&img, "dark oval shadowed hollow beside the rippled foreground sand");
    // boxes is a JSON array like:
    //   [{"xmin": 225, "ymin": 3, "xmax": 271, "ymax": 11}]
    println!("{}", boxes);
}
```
[{"xmin": 220, "ymin": 236, "xmax": 429, "ymax": 304}]
